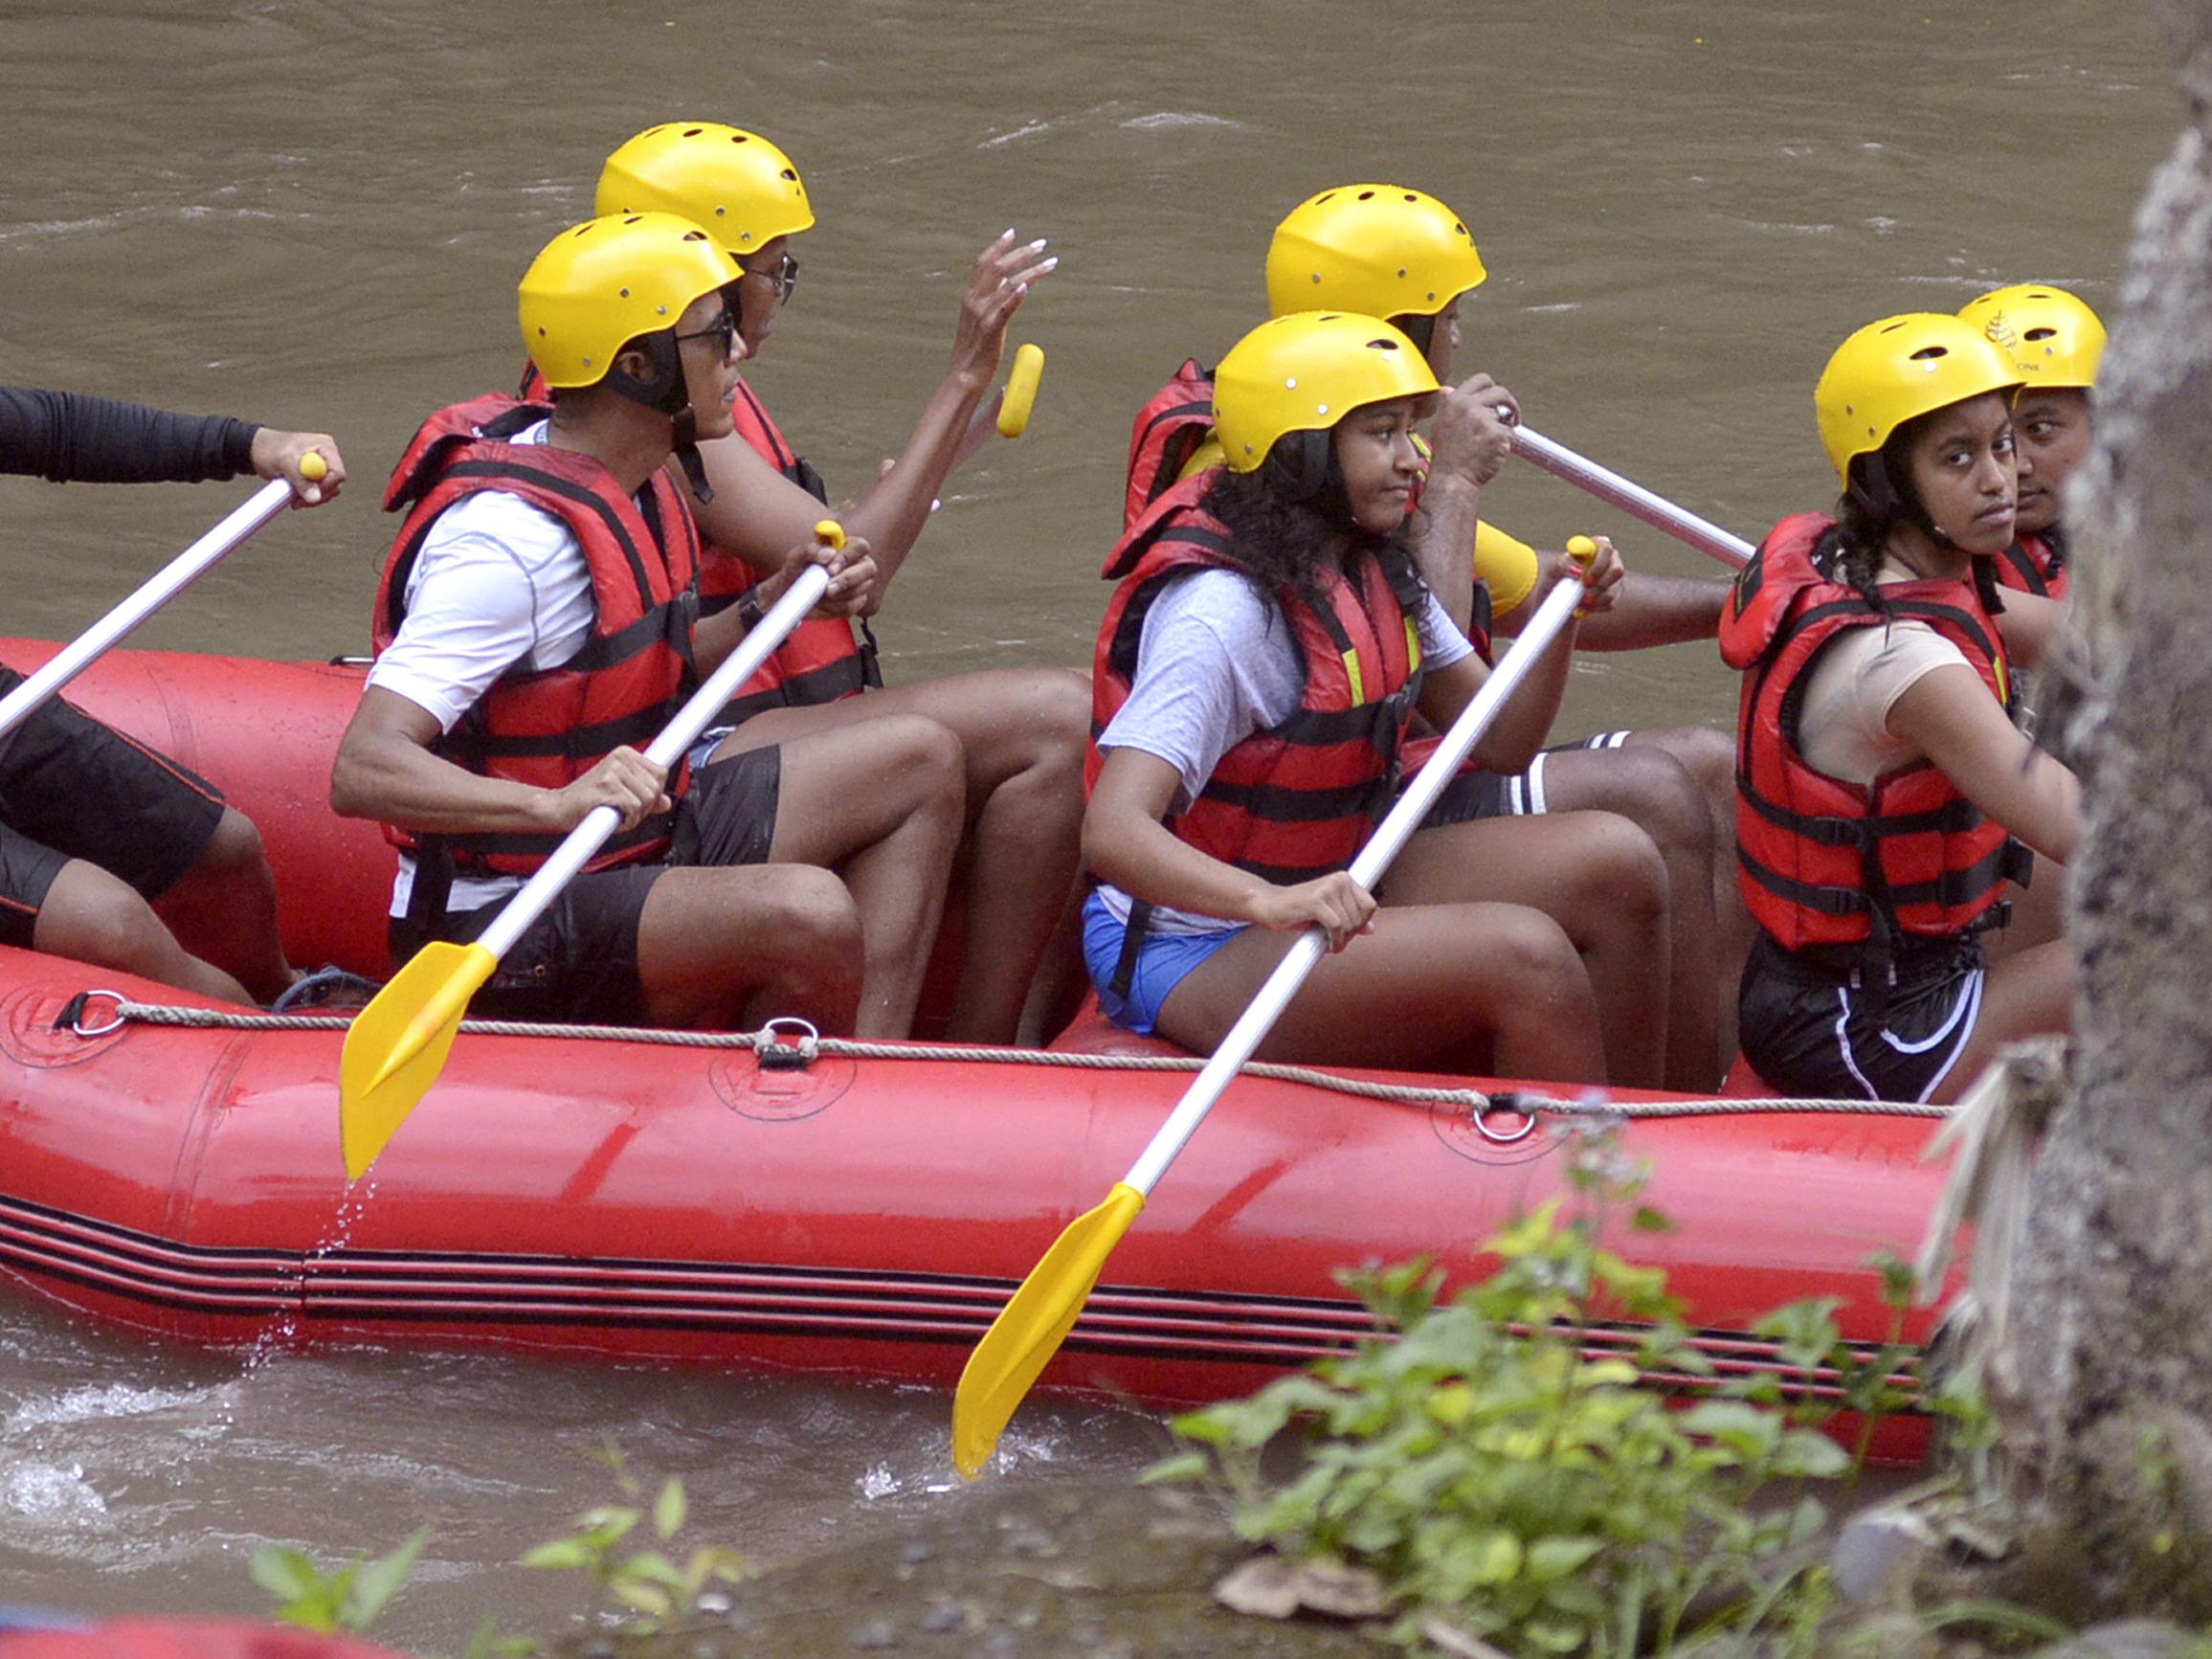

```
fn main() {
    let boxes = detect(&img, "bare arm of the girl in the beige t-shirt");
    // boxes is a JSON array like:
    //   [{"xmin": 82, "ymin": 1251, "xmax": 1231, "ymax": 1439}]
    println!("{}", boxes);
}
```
[{"xmin": 1889, "ymin": 663, "xmax": 2082, "ymax": 864}]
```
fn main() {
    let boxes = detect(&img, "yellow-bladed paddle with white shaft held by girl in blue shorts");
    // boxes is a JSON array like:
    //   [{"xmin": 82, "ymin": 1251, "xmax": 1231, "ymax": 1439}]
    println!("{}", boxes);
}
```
[{"xmin": 953, "ymin": 535, "xmax": 1598, "ymax": 1478}]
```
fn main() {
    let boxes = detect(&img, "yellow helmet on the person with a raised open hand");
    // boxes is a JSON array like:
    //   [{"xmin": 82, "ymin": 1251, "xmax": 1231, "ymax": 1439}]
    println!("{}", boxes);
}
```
[{"xmin": 592, "ymin": 122, "xmax": 814, "ymax": 255}]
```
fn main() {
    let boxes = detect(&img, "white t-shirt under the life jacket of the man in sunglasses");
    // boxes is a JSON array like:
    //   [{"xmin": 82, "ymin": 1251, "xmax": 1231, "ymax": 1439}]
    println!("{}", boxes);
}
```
[{"xmin": 368, "ymin": 420, "xmax": 599, "ymax": 916}]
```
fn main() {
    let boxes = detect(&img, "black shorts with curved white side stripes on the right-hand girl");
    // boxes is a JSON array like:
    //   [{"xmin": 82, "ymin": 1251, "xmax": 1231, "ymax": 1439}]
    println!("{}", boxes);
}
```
[{"xmin": 1736, "ymin": 933, "xmax": 1984, "ymax": 1102}]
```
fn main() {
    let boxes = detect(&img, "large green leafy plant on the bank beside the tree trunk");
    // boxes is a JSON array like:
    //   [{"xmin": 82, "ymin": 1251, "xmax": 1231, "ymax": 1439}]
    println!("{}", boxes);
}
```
[{"xmin": 1146, "ymin": 1139, "xmax": 1907, "ymax": 1657}]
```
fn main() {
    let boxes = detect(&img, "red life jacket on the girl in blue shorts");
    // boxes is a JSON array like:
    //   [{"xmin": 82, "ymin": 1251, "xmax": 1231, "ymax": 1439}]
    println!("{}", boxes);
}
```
[{"xmin": 1084, "ymin": 478, "xmax": 1422, "ymax": 885}]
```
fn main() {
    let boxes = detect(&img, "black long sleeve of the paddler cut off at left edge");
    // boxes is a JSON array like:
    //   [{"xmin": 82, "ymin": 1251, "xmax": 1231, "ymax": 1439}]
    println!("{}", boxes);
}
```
[{"xmin": 0, "ymin": 385, "xmax": 258, "ymax": 484}]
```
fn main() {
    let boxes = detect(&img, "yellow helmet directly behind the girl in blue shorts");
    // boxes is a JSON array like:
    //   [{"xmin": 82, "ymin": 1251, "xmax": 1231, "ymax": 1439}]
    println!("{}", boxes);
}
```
[{"xmin": 1267, "ymin": 184, "xmax": 1488, "ymax": 316}]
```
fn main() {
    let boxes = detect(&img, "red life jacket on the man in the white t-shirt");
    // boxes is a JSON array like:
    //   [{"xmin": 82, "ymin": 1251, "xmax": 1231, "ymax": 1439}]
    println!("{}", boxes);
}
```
[{"xmin": 374, "ymin": 396, "xmax": 699, "ymax": 885}]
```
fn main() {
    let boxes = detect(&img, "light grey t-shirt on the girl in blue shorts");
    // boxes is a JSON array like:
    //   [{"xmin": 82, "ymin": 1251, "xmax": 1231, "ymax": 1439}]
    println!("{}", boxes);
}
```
[{"xmin": 1100, "ymin": 571, "xmax": 1473, "ymax": 933}]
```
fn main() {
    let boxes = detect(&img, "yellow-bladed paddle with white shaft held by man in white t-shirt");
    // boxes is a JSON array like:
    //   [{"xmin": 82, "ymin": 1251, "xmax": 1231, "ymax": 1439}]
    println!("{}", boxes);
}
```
[{"xmin": 339, "ymin": 520, "xmax": 845, "ymax": 1181}]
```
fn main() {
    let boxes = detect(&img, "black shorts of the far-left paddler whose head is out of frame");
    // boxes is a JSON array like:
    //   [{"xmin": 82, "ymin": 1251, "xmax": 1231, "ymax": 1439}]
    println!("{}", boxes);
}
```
[{"xmin": 0, "ymin": 668, "xmax": 223, "ymax": 947}]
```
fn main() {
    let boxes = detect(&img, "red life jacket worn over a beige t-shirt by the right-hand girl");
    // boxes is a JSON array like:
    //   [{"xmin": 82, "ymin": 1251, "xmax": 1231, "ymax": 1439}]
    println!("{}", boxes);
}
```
[{"xmin": 1721, "ymin": 513, "xmax": 2024, "ymax": 955}]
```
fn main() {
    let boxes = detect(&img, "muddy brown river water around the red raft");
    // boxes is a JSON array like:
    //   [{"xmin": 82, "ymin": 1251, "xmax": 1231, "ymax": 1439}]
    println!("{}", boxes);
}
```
[{"xmin": 0, "ymin": 0, "xmax": 2178, "ymax": 1652}]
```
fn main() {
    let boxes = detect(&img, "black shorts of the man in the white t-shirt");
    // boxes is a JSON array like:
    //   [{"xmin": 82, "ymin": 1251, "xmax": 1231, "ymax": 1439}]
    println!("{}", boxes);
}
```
[{"xmin": 391, "ymin": 748, "xmax": 783, "ymax": 1026}]
